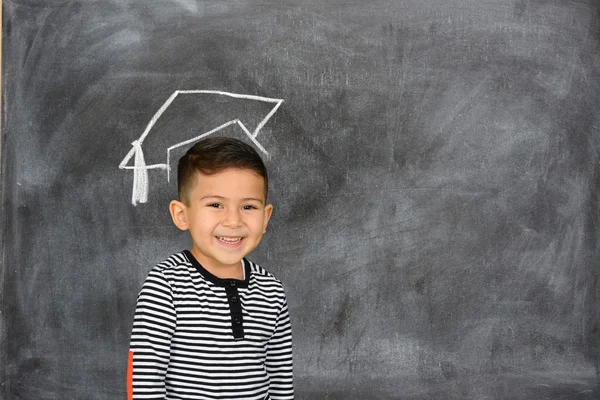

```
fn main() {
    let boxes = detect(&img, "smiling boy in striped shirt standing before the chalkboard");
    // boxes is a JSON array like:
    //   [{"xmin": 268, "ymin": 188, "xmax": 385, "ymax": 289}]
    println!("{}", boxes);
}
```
[{"xmin": 127, "ymin": 138, "xmax": 294, "ymax": 400}]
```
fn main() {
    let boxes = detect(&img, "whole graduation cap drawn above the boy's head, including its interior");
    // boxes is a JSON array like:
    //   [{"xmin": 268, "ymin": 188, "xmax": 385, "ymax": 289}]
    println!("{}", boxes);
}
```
[{"xmin": 119, "ymin": 90, "xmax": 283, "ymax": 206}]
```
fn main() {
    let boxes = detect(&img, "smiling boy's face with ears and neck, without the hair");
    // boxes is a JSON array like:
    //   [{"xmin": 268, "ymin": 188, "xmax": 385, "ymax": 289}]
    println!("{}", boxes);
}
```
[{"xmin": 169, "ymin": 168, "xmax": 273, "ymax": 277}]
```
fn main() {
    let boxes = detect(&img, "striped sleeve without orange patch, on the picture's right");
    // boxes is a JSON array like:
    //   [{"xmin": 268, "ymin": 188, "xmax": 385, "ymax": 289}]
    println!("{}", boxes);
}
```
[{"xmin": 265, "ymin": 300, "xmax": 294, "ymax": 400}]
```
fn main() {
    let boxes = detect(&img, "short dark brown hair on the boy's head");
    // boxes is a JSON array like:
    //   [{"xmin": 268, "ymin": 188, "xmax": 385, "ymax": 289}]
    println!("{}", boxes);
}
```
[{"xmin": 177, "ymin": 137, "xmax": 269, "ymax": 205}]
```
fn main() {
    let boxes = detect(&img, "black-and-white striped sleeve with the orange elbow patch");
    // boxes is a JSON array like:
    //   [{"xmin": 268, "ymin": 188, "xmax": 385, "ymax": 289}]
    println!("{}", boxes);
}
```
[{"xmin": 127, "ymin": 268, "xmax": 177, "ymax": 400}]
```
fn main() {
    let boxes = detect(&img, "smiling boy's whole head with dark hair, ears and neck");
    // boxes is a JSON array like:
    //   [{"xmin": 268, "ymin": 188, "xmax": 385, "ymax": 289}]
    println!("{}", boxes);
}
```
[{"xmin": 169, "ymin": 138, "xmax": 273, "ymax": 278}]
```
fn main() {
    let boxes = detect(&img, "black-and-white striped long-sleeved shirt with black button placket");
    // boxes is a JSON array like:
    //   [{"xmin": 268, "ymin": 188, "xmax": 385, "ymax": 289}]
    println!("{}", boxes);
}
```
[{"xmin": 127, "ymin": 251, "xmax": 294, "ymax": 400}]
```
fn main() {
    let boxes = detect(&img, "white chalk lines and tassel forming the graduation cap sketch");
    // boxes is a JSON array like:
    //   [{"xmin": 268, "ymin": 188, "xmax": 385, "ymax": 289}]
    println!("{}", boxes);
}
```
[{"xmin": 119, "ymin": 90, "xmax": 283, "ymax": 206}]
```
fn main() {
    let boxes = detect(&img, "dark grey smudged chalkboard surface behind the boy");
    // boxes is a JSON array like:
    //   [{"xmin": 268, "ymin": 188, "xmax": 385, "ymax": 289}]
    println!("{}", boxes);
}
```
[{"xmin": 0, "ymin": 0, "xmax": 600, "ymax": 400}]
